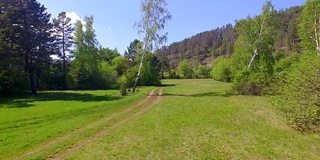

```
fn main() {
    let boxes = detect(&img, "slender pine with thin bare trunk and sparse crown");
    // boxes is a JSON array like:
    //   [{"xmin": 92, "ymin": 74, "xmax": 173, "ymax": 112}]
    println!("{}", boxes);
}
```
[{"xmin": 53, "ymin": 12, "xmax": 75, "ymax": 89}]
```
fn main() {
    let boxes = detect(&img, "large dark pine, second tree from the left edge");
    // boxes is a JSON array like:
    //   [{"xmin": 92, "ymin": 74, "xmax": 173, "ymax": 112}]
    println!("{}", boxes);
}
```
[{"xmin": 13, "ymin": 0, "xmax": 53, "ymax": 94}]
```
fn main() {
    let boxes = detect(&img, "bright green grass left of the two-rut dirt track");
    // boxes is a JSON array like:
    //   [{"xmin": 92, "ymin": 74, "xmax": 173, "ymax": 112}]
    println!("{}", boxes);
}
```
[{"xmin": 0, "ymin": 87, "xmax": 154, "ymax": 159}]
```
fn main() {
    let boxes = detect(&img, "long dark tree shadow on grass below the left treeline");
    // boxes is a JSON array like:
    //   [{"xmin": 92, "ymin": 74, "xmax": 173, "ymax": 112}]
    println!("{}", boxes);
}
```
[{"xmin": 0, "ymin": 92, "xmax": 121, "ymax": 108}]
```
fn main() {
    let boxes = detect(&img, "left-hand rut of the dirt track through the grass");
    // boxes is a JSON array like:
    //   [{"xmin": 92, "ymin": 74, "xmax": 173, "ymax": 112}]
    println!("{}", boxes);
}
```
[{"xmin": 10, "ymin": 89, "xmax": 156, "ymax": 160}]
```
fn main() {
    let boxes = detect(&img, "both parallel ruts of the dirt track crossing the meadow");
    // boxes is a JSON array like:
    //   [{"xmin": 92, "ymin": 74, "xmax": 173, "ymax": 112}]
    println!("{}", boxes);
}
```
[{"xmin": 10, "ymin": 88, "xmax": 163, "ymax": 159}]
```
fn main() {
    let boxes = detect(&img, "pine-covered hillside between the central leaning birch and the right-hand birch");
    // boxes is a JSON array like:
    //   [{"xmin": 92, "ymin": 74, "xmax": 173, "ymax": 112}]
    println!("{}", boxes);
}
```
[{"xmin": 159, "ymin": 24, "xmax": 237, "ymax": 71}]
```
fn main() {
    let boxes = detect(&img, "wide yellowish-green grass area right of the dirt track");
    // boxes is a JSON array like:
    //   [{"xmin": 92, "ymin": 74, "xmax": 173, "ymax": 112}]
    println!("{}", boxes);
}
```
[{"xmin": 68, "ymin": 80, "xmax": 320, "ymax": 160}]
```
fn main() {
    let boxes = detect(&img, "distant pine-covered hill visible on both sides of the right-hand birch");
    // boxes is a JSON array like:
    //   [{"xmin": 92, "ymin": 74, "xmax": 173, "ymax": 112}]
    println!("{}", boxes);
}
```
[{"xmin": 158, "ymin": 6, "xmax": 302, "ymax": 69}]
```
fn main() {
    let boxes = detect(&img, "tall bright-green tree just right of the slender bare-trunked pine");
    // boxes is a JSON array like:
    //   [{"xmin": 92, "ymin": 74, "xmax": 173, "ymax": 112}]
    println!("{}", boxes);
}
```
[{"xmin": 71, "ymin": 16, "xmax": 101, "ymax": 89}]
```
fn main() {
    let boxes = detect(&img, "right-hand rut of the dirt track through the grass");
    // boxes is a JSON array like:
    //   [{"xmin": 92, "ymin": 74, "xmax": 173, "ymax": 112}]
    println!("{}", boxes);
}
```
[{"xmin": 47, "ymin": 88, "xmax": 163, "ymax": 160}]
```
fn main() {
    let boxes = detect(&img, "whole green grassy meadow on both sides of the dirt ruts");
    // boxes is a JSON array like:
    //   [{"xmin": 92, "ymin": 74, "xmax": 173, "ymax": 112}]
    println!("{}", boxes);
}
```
[{"xmin": 0, "ymin": 80, "xmax": 320, "ymax": 160}]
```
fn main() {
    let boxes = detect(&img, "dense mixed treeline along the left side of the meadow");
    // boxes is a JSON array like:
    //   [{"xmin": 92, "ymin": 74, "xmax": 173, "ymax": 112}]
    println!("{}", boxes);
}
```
[{"xmin": 0, "ymin": 0, "xmax": 161, "ymax": 94}]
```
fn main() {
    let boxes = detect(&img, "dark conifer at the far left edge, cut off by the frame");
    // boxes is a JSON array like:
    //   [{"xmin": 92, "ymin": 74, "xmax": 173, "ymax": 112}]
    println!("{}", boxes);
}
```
[{"xmin": 0, "ymin": 0, "xmax": 28, "ymax": 94}]
